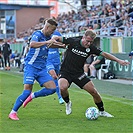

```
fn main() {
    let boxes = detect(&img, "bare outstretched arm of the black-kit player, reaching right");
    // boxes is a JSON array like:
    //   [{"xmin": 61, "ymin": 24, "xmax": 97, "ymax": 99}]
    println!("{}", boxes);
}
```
[{"xmin": 101, "ymin": 52, "xmax": 130, "ymax": 65}]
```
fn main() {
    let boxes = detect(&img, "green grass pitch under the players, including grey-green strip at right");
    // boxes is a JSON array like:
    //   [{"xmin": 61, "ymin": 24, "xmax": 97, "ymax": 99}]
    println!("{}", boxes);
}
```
[{"xmin": 0, "ymin": 71, "xmax": 133, "ymax": 133}]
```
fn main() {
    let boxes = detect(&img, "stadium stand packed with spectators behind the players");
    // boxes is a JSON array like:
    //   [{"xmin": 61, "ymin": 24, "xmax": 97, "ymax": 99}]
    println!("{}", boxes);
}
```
[{"xmin": 14, "ymin": 0, "xmax": 133, "ymax": 38}]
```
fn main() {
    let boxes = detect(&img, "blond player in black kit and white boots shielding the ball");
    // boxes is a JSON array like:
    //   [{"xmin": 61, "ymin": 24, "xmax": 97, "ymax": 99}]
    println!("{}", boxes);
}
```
[{"xmin": 55, "ymin": 30, "xmax": 129, "ymax": 117}]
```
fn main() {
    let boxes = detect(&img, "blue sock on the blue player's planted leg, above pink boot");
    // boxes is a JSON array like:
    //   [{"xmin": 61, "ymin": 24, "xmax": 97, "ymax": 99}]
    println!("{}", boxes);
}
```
[{"xmin": 13, "ymin": 90, "xmax": 31, "ymax": 112}]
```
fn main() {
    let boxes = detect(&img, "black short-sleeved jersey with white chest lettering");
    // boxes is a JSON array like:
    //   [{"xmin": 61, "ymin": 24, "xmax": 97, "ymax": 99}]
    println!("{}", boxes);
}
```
[{"xmin": 60, "ymin": 37, "xmax": 102, "ymax": 73}]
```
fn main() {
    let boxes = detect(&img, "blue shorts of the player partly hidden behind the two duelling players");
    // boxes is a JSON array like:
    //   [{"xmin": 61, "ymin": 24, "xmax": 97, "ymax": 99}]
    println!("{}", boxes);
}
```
[{"xmin": 46, "ymin": 62, "xmax": 60, "ymax": 74}]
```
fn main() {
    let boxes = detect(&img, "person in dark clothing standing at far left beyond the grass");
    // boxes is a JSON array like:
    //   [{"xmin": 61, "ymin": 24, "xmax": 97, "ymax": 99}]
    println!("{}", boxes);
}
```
[{"xmin": 2, "ymin": 39, "xmax": 11, "ymax": 70}]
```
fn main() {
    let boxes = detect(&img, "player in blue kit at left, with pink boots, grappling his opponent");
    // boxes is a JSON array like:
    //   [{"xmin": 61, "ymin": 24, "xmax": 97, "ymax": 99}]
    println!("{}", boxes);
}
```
[{"xmin": 8, "ymin": 19, "xmax": 63, "ymax": 120}]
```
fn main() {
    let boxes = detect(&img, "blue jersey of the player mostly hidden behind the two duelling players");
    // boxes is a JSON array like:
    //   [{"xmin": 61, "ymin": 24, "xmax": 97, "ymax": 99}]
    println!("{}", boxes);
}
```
[{"xmin": 47, "ymin": 31, "xmax": 61, "ymax": 65}]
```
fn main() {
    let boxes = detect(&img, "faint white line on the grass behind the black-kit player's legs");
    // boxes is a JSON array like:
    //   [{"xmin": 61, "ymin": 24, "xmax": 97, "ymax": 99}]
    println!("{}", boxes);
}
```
[{"xmin": 70, "ymin": 89, "xmax": 133, "ymax": 106}]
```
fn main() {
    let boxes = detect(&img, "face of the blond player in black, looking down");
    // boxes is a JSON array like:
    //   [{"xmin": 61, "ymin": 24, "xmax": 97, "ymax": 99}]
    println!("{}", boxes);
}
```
[{"xmin": 82, "ymin": 36, "xmax": 93, "ymax": 48}]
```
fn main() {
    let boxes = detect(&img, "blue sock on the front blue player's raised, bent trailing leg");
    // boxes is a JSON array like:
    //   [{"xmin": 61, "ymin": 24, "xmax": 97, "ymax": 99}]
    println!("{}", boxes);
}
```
[{"xmin": 34, "ymin": 88, "xmax": 56, "ymax": 98}]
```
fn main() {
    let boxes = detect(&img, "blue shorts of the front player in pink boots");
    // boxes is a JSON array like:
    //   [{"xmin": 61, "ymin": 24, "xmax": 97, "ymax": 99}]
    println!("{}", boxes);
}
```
[{"xmin": 23, "ymin": 65, "xmax": 53, "ymax": 87}]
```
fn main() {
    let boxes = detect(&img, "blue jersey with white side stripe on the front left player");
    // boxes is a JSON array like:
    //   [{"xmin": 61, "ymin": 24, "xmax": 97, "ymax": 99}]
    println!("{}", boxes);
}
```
[{"xmin": 25, "ymin": 30, "xmax": 51, "ymax": 69}]
